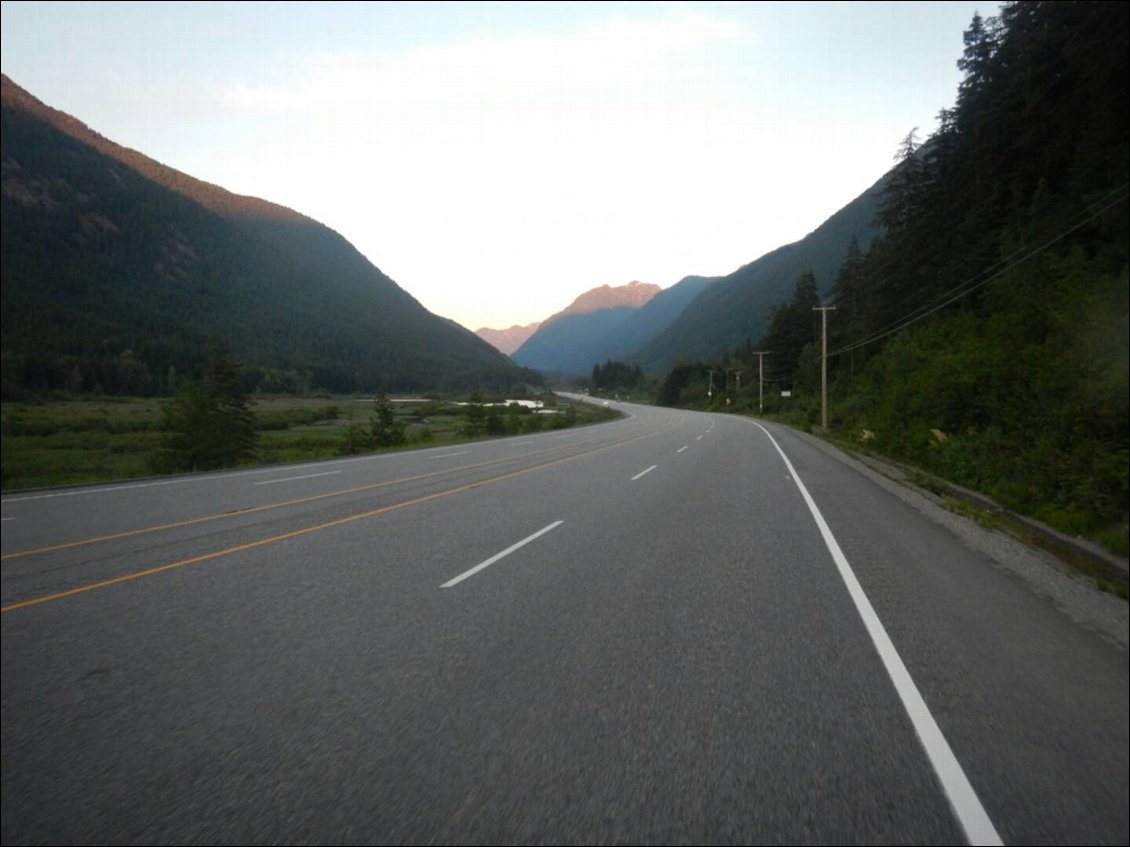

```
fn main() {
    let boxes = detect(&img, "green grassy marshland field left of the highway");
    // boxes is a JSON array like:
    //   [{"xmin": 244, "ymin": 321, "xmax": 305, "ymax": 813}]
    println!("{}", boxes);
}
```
[{"xmin": 0, "ymin": 396, "xmax": 616, "ymax": 491}]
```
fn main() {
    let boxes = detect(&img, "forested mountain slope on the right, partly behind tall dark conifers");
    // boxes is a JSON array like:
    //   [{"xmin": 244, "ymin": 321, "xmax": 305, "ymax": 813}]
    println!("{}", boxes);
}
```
[{"xmin": 628, "ymin": 176, "xmax": 887, "ymax": 374}]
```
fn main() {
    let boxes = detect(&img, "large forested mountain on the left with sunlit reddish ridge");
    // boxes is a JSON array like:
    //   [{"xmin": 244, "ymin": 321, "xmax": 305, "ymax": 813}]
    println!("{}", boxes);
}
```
[{"xmin": 0, "ymin": 76, "xmax": 531, "ymax": 398}]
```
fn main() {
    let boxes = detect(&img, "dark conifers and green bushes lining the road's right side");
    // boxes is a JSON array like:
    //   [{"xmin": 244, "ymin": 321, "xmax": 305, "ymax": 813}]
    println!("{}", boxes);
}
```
[{"xmin": 658, "ymin": 3, "xmax": 1130, "ymax": 571}]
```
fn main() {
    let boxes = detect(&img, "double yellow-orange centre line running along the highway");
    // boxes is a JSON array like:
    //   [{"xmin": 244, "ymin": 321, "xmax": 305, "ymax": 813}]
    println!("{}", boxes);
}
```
[{"xmin": 0, "ymin": 430, "xmax": 662, "ymax": 614}]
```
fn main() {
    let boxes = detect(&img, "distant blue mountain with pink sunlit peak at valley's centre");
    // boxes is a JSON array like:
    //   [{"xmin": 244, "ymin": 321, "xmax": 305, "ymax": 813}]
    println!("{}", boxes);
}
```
[{"xmin": 511, "ymin": 282, "xmax": 660, "ymax": 376}]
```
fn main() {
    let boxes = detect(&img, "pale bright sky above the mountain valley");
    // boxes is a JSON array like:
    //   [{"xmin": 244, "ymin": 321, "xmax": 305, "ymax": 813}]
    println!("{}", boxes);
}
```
[{"xmin": 0, "ymin": 0, "xmax": 999, "ymax": 330}]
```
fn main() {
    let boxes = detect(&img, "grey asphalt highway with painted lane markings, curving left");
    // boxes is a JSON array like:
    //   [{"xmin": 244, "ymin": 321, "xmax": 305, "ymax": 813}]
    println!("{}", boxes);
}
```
[{"xmin": 0, "ymin": 407, "xmax": 1130, "ymax": 845}]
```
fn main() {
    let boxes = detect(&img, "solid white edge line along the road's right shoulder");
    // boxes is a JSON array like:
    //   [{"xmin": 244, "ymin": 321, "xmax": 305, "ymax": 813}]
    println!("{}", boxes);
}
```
[{"xmin": 750, "ymin": 421, "xmax": 1003, "ymax": 845}]
